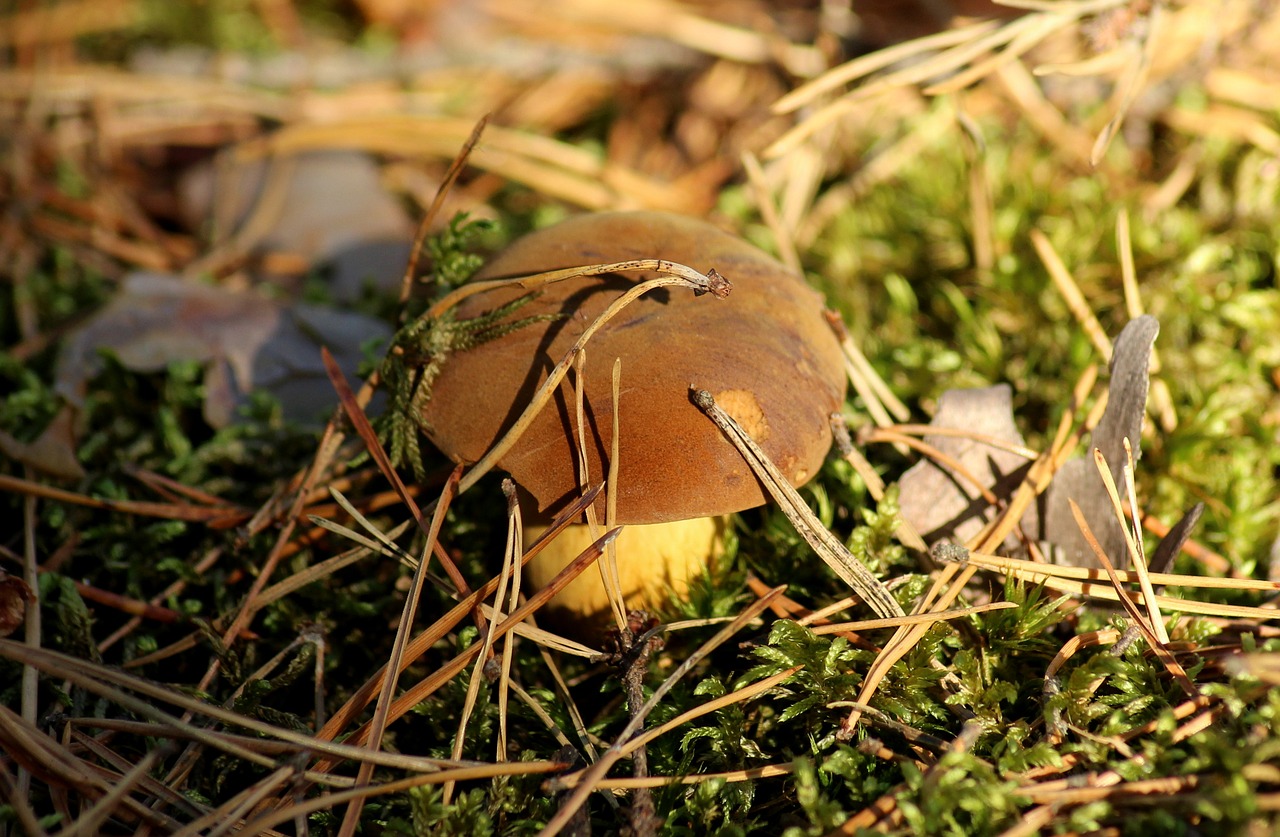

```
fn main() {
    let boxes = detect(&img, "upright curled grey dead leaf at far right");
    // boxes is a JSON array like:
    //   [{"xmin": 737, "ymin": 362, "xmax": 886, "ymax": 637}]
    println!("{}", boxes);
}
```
[{"xmin": 1043, "ymin": 315, "xmax": 1160, "ymax": 570}]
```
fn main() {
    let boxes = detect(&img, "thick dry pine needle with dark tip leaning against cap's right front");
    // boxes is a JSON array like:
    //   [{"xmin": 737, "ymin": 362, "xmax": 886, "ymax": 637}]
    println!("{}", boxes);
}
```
[{"xmin": 691, "ymin": 387, "xmax": 904, "ymax": 618}]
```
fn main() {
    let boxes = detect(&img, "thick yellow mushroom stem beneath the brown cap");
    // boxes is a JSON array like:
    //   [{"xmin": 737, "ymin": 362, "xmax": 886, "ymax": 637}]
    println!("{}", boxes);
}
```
[{"xmin": 524, "ymin": 516, "xmax": 728, "ymax": 627}]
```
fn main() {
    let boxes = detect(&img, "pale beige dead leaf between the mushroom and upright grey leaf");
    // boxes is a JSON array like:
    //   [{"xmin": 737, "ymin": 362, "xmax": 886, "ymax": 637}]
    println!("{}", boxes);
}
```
[{"xmin": 899, "ymin": 384, "xmax": 1036, "ymax": 543}]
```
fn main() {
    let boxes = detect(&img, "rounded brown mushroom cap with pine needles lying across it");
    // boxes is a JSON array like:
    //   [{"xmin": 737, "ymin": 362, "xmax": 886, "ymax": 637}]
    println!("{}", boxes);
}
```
[{"xmin": 426, "ymin": 212, "xmax": 845, "ymax": 523}]
